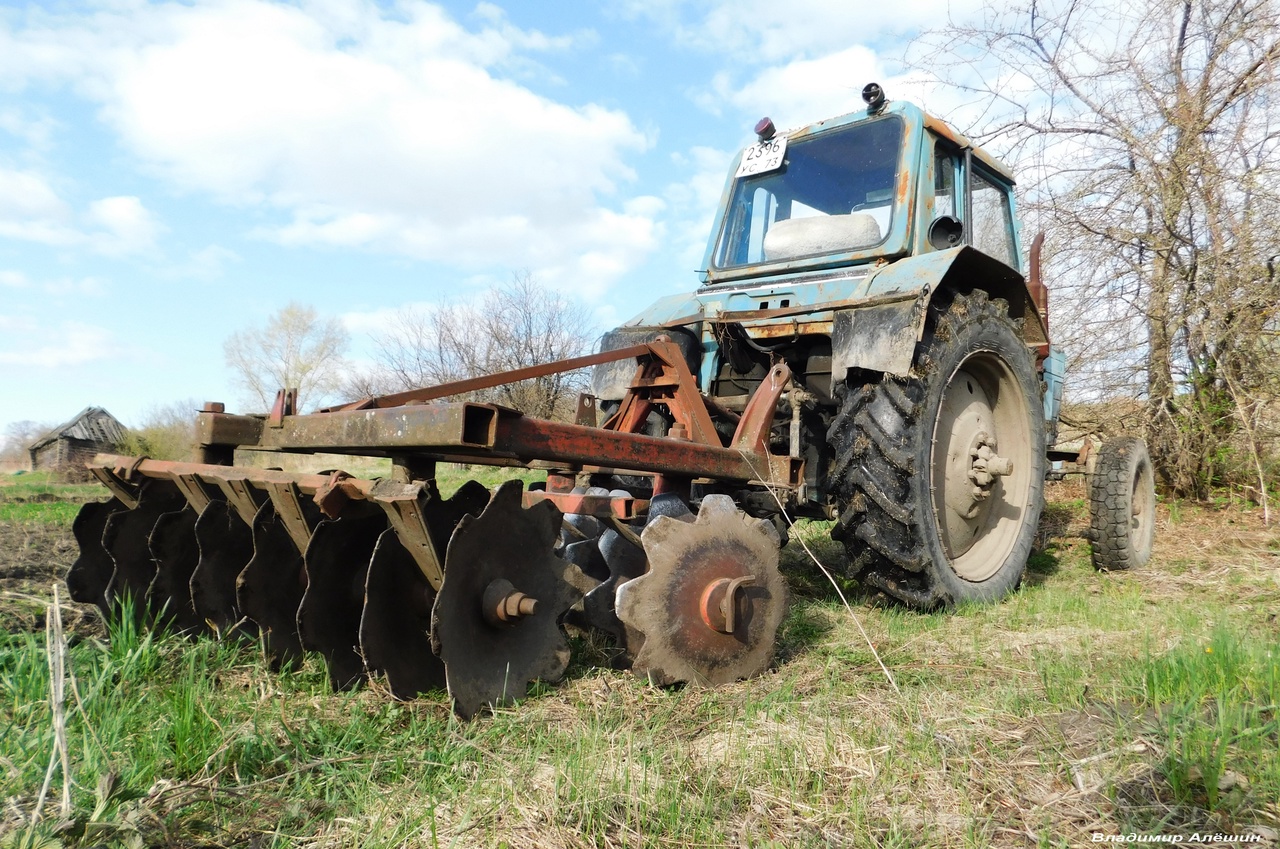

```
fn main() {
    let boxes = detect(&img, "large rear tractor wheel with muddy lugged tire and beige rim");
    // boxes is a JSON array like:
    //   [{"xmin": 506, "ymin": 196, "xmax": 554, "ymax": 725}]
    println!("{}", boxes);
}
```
[{"xmin": 827, "ymin": 291, "xmax": 1046, "ymax": 608}]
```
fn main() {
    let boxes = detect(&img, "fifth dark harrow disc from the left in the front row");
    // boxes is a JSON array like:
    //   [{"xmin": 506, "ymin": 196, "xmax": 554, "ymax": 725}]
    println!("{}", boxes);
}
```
[{"xmin": 236, "ymin": 501, "xmax": 320, "ymax": 668}]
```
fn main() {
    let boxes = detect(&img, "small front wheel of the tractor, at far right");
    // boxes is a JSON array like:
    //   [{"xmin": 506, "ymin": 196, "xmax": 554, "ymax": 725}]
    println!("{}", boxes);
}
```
[{"xmin": 1089, "ymin": 437, "xmax": 1156, "ymax": 571}]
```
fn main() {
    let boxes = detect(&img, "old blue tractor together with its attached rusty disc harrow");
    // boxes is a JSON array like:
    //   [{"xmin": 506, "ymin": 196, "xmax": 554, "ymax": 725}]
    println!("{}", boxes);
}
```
[{"xmin": 67, "ymin": 96, "xmax": 1155, "ymax": 716}]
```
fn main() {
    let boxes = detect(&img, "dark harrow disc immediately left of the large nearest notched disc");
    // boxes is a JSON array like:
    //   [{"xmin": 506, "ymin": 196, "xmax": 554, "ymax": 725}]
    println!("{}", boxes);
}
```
[{"xmin": 360, "ymin": 529, "xmax": 444, "ymax": 699}]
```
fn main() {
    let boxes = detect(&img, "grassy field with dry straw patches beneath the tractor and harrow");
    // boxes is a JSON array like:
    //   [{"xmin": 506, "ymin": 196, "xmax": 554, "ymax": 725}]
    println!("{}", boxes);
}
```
[{"xmin": 0, "ymin": 475, "xmax": 1280, "ymax": 848}]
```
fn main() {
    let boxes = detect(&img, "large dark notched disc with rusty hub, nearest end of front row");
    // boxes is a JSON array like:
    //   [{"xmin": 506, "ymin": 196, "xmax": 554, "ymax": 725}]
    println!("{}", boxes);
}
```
[{"xmin": 431, "ymin": 480, "xmax": 580, "ymax": 717}]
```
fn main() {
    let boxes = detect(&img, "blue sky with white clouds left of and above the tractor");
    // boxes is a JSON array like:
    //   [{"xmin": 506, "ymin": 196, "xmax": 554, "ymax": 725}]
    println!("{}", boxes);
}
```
[{"xmin": 0, "ymin": 0, "xmax": 977, "ymax": 440}]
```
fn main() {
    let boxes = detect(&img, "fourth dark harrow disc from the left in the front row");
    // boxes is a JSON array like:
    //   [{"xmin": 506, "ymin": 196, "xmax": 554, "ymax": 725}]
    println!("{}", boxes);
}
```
[{"xmin": 191, "ymin": 501, "xmax": 257, "ymax": 636}]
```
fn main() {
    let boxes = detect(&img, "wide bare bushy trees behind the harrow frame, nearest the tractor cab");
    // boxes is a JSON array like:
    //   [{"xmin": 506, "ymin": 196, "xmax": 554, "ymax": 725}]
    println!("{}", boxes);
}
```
[{"xmin": 347, "ymin": 273, "xmax": 595, "ymax": 419}]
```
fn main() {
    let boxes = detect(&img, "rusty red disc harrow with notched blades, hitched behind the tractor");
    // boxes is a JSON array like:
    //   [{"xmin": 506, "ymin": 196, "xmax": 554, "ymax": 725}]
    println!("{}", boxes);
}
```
[{"xmin": 68, "ymin": 342, "xmax": 801, "ymax": 717}]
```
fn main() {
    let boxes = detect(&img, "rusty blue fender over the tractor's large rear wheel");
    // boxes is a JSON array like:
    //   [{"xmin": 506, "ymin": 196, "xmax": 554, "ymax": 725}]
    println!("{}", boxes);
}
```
[{"xmin": 831, "ymin": 246, "xmax": 1048, "ymax": 382}]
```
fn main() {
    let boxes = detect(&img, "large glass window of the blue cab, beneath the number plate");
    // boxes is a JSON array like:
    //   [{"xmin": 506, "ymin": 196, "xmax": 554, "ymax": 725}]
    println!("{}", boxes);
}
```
[{"xmin": 714, "ymin": 115, "xmax": 902, "ymax": 269}]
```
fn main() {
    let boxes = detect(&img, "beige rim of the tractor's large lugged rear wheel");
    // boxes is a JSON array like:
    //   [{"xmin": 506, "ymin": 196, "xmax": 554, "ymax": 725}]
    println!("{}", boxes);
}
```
[{"xmin": 932, "ymin": 351, "xmax": 1034, "ymax": 581}]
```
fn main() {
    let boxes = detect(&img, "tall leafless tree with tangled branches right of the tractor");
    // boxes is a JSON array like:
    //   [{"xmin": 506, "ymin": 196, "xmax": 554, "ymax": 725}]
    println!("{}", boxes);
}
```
[{"xmin": 923, "ymin": 0, "xmax": 1280, "ymax": 501}]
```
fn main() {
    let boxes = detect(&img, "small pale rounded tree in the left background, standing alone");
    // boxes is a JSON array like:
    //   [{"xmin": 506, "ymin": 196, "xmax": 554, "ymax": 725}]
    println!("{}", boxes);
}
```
[{"xmin": 223, "ymin": 303, "xmax": 349, "ymax": 411}]
